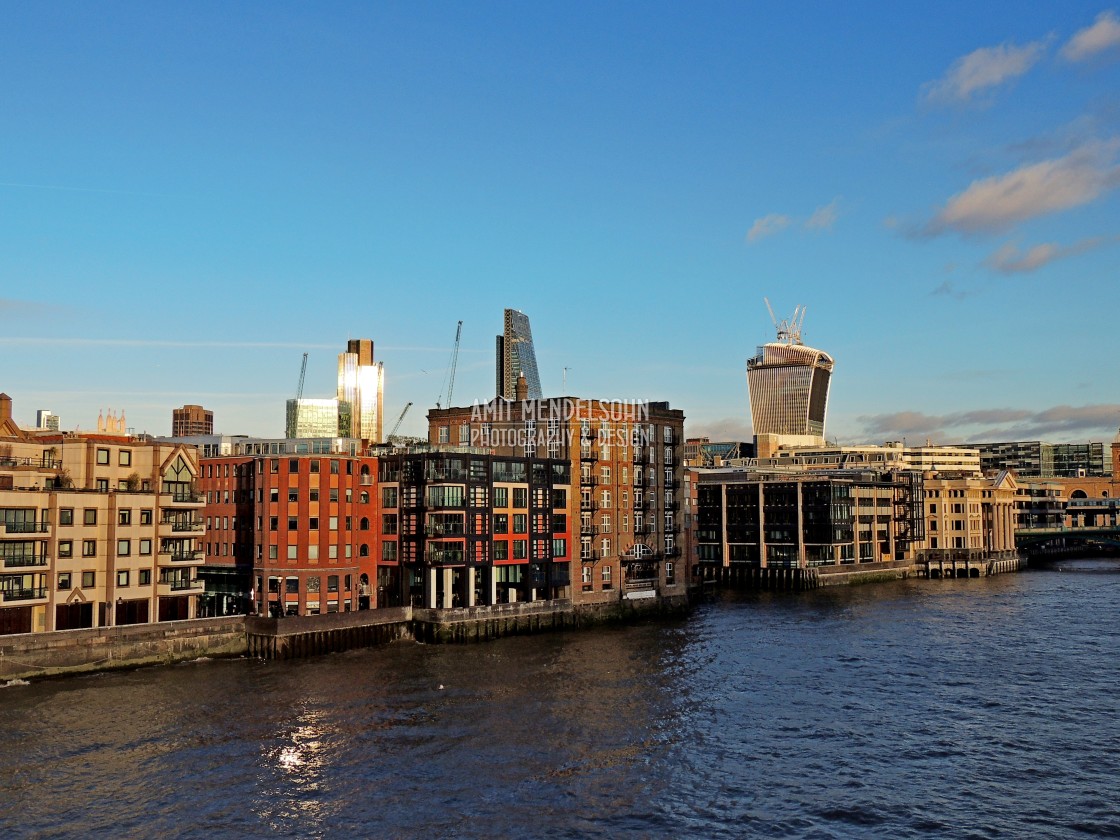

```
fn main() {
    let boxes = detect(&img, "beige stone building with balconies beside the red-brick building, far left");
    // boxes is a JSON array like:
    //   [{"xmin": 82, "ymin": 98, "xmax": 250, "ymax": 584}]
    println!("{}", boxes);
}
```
[{"xmin": 0, "ymin": 394, "xmax": 204, "ymax": 633}]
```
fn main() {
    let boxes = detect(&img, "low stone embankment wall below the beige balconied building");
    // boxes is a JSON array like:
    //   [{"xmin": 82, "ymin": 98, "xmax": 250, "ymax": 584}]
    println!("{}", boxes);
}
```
[{"xmin": 0, "ymin": 616, "xmax": 245, "ymax": 681}]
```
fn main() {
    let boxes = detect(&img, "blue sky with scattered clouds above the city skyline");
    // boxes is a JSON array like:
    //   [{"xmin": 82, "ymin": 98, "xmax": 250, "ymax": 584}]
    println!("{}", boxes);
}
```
[{"xmin": 0, "ymin": 1, "xmax": 1120, "ymax": 442}]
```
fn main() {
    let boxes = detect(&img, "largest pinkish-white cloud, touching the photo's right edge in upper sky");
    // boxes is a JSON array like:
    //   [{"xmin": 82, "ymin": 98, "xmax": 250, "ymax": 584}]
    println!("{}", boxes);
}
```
[{"xmin": 924, "ymin": 142, "xmax": 1120, "ymax": 234}]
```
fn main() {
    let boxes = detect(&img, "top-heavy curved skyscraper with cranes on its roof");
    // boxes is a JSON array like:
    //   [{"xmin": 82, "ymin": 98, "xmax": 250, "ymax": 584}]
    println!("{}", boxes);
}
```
[{"xmin": 747, "ymin": 342, "xmax": 833, "ymax": 437}]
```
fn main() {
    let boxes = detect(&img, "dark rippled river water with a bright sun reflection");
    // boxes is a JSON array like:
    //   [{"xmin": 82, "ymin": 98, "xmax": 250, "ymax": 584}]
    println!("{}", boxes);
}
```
[{"xmin": 0, "ymin": 560, "xmax": 1120, "ymax": 838}]
